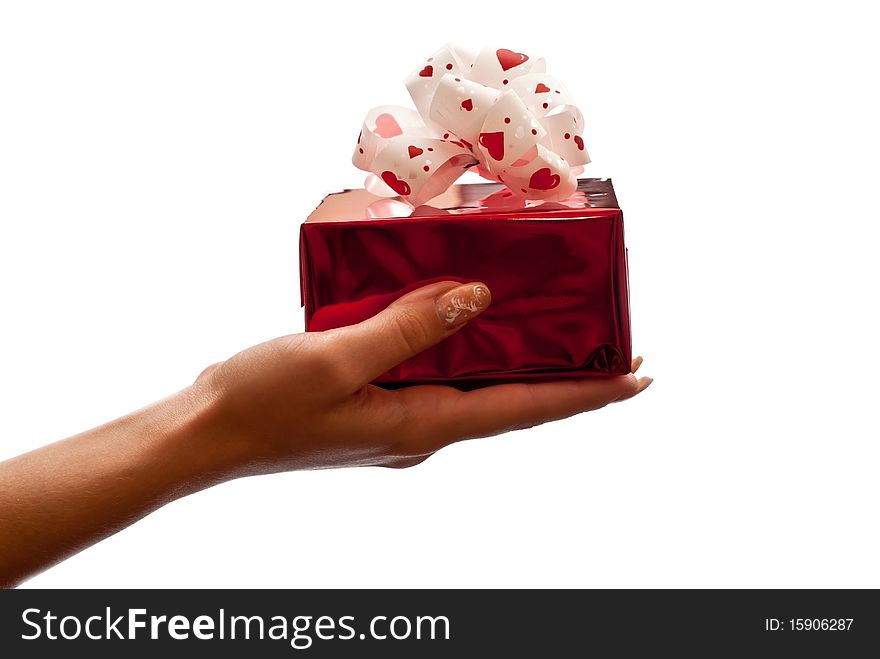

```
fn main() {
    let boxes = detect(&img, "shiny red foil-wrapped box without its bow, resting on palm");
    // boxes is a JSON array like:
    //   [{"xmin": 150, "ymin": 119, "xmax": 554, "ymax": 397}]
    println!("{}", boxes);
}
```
[{"xmin": 300, "ymin": 179, "xmax": 631, "ymax": 387}]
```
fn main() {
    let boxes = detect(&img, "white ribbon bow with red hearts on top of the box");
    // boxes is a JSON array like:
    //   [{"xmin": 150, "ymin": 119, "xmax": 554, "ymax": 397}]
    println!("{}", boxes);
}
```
[{"xmin": 352, "ymin": 45, "xmax": 590, "ymax": 206}]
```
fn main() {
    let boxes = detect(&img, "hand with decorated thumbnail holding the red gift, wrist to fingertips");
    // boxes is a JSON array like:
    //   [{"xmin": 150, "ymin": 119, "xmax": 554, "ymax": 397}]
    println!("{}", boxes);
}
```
[{"xmin": 194, "ymin": 282, "xmax": 651, "ymax": 475}]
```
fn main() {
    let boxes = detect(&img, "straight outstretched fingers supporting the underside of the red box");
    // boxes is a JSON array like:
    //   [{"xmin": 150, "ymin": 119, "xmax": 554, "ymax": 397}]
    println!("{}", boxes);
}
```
[{"xmin": 395, "ymin": 374, "xmax": 650, "ymax": 451}]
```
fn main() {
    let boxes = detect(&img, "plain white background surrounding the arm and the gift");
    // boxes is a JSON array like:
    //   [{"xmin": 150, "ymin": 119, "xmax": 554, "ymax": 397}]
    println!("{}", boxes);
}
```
[{"xmin": 0, "ymin": 0, "xmax": 880, "ymax": 587}]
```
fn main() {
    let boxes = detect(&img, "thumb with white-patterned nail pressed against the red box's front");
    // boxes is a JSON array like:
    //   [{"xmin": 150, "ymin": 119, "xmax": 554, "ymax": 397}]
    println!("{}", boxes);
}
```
[{"xmin": 338, "ymin": 281, "xmax": 492, "ymax": 385}]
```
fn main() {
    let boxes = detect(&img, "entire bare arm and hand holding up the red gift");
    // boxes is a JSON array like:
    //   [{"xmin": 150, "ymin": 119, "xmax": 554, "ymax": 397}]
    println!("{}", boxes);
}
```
[{"xmin": 0, "ymin": 282, "xmax": 651, "ymax": 587}]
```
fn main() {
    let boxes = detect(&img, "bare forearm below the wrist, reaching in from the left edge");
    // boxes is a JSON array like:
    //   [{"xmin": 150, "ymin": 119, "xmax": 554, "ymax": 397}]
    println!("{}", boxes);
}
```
[{"xmin": 0, "ymin": 389, "xmax": 232, "ymax": 586}]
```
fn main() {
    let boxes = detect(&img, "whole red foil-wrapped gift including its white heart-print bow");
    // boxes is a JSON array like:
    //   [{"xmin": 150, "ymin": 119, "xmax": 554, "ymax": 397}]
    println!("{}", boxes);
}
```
[{"xmin": 300, "ymin": 44, "xmax": 631, "ymax": 388}]
